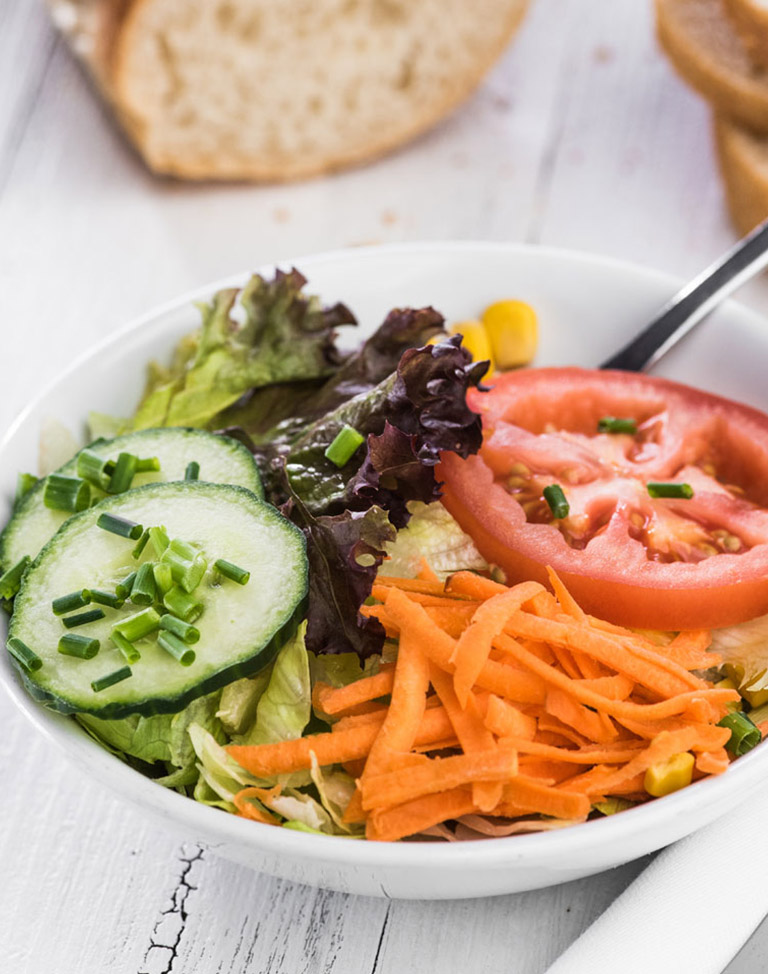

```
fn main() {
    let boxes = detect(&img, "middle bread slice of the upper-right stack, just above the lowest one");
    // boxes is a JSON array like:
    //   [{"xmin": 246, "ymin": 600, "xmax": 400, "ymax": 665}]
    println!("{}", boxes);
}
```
[{"xmin": 656, "ymin": 0, "xmax": 768, "ymax": 133}]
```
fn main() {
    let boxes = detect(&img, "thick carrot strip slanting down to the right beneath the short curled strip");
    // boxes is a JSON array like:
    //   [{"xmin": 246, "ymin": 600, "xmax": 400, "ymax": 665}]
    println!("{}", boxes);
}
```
[{"xmin": 387, "ymin": 576, "xmax": 548, "ymax": 703}]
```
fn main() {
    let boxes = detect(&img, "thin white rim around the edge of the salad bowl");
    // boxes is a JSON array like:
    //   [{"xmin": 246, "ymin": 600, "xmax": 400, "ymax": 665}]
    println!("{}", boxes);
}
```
[{"xmin": 0, "ymin": 240, "xmax": 768, "ymax": 871}]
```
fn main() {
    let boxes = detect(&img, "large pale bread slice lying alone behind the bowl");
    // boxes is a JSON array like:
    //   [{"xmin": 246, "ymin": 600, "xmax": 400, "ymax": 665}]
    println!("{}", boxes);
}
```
[{"xmin": 49, "ymin": 0, "xmax": 528, "ymax": 180}]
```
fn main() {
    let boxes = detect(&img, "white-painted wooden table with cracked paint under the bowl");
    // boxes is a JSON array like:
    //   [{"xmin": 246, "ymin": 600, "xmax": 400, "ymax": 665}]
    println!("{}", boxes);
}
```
[{"xmin": 0, "ymin": 0, "xmax": 768, "ymax": 974}]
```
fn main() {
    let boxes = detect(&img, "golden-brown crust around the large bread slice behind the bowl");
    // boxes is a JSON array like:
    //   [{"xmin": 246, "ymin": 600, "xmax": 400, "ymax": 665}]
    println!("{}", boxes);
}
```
[{"xmin": 49, "ymin": 0, "xmax": 529, "ymax": 182}]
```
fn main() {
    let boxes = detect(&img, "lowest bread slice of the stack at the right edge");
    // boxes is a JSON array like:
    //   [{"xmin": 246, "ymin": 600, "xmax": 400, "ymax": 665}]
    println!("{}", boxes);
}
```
[{"xmin": 714, "ymin": 116, "xmax": 768, "ymax": 234}]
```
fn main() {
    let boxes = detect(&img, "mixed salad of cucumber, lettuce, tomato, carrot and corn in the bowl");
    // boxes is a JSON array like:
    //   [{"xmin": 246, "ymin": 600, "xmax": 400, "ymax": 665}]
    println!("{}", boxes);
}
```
[{"xmin": 0, "ymin": 270, "xmax": 768, "ymax": 841}]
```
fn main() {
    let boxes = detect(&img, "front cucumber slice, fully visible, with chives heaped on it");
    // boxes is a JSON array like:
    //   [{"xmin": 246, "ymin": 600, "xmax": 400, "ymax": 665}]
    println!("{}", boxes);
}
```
[{"xmin": 9, "ymin": 482, "xmax": 308, "ymax": 718}]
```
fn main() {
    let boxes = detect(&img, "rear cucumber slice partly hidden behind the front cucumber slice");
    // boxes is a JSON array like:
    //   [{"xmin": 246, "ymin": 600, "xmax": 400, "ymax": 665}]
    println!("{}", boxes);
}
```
[{"xmin": 0, "ymin": 427, "xmax": 264, "ymax": 570}]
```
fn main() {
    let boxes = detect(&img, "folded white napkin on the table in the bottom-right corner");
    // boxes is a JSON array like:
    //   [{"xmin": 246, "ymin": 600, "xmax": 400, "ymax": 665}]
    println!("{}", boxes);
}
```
[{"xmin": 547, "ymin": 789, "xmax": 768, "ymax": 974}]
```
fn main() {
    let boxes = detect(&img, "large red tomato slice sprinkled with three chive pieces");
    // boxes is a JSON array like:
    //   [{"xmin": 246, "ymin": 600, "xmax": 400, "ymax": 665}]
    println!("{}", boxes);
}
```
[{"xmin": 438, "ymin": 368, "xmax": 768, "ymax": 630}]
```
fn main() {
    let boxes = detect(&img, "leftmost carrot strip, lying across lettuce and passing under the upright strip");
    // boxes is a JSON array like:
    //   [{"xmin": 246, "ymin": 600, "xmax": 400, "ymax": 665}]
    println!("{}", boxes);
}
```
[{"xmin": 227, "ymin": 707, "xmax": 453, "ymax": 778}]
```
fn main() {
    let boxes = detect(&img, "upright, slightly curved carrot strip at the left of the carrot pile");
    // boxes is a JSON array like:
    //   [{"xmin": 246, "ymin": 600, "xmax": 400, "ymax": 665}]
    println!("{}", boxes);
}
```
[{"xmin": 363, "ymin": 631, "xmax": 429, "ymax": 779}]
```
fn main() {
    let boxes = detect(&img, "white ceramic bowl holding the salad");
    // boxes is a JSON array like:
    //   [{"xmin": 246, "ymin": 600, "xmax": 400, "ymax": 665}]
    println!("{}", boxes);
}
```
[{"xmin": 0, "ymin": 243, "xmax": 768, "ymax": 898}]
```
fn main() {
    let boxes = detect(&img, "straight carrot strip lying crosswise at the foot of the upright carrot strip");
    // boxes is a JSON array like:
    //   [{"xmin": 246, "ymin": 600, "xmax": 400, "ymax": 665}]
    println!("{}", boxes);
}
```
[{"xmin": 361, "ymin": 745, "xmax": 517, "ymax": 811}]
